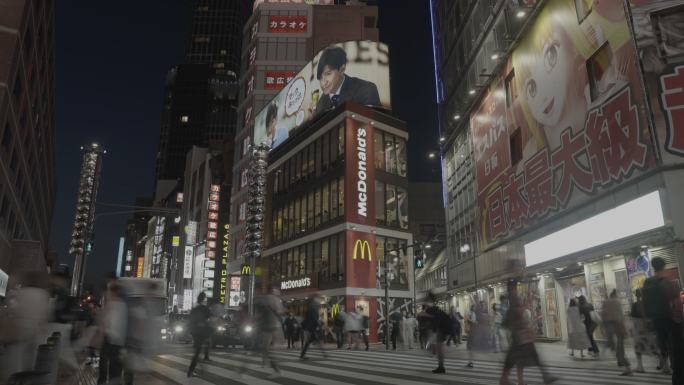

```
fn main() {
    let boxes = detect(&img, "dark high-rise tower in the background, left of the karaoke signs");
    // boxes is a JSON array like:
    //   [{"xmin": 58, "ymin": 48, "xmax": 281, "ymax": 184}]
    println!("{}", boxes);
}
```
[{"xmin": 155, "ymin": 0, "xmax": 252, "ymax": 186}]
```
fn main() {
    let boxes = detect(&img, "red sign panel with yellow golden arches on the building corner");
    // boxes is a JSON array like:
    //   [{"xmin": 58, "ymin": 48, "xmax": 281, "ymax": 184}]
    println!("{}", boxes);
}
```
[{"xmin": 346, "ymin": 230, "xmax": 378, "ymax": 288}]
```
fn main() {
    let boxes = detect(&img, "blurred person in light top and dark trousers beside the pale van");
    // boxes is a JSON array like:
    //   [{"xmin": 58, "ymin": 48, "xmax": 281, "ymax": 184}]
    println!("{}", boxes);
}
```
[{"xmin": 97, "ymin": 281, "xmax": 132, "ymax": 384}]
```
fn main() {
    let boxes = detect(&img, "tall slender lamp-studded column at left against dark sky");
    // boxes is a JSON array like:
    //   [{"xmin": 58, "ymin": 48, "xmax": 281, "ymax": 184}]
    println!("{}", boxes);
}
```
[{"xmin": 69, "ymin": 143, "xmax": 107, "ymax": 295}]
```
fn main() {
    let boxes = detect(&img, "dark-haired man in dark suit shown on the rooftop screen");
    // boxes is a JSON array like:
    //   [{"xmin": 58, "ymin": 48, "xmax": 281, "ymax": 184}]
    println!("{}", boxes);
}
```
[{"xmin": 316, "ymin": 46, "xmax": 380, "ymax": 114}]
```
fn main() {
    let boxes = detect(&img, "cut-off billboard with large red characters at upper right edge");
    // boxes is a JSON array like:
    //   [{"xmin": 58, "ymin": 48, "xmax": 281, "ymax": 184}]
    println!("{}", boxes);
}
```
[{"xmin": 630, "ymin": 0, "xmax": 684, "ymax": 164}]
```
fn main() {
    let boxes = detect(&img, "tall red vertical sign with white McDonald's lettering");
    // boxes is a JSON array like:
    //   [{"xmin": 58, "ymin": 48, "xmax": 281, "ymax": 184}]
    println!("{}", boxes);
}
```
[{"xmin": 344, "ymin": 118, "xmax": 375, "ymax": 226}]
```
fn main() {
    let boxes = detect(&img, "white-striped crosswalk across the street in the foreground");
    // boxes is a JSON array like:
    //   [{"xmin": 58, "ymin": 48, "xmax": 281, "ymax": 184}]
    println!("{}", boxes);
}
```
[{"xmin": 144, "ymin": 344, "xmax": 671, "ymax": 385}]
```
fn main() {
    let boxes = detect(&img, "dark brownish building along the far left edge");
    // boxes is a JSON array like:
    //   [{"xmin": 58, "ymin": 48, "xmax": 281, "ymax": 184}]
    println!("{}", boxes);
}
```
[{"xmin": 0, "ymin": 0, "xmax": 56, "ymax": 284}]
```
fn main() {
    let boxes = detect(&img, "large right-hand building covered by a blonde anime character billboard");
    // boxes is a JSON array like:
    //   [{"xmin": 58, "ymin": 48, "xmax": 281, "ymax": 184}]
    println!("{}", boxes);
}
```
[{"xmin": 430, "ymin": 0, "xmax": 684, "ymax": 340}]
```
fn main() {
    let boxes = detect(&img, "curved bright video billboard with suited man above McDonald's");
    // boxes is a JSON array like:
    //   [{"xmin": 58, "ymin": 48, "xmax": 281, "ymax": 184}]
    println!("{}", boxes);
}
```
[{"xmin": 254, "ymin": 41, "xmax": 391, "ymax": 148}]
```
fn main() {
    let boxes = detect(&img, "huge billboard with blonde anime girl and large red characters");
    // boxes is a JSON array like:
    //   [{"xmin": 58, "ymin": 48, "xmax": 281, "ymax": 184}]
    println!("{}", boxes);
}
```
[{"xmin": 470, "ymin": 0, "xmax": 656, "ymax": 248}]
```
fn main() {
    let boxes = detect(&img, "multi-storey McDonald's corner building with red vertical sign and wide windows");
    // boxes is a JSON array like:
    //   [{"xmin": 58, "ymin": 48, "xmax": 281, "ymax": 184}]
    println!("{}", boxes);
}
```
[{"xmin": 258, "ymin": 102, "xmax": 413, "ymax": 340}]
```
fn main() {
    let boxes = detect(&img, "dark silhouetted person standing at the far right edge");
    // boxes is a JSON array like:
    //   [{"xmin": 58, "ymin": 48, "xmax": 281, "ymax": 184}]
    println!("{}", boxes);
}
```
[{"xmin": 642, "ymin": 257, "xmax": 684, "ymax": 385}]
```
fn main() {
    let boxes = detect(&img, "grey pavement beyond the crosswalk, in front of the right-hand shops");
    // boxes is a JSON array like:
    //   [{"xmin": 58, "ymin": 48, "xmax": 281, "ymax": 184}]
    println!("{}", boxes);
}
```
[{"xmin": 371, "ymin": 342, "xmax": 657, "ymax": 373}]
